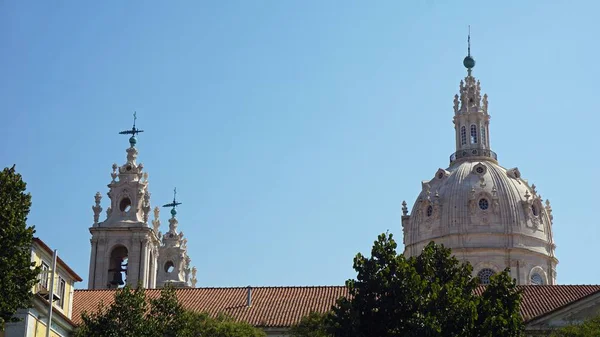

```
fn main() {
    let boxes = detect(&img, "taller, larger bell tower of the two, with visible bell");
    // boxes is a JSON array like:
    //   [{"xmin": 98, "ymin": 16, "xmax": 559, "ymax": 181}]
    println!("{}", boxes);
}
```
[{"xmin": 88, "ymin": 113, "xmax": 159, "ymax": 289}]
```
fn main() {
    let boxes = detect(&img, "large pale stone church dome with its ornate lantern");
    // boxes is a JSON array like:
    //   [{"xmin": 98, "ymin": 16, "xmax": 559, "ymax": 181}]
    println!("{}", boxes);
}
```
[{"xmin": 402, "ymin": 48, "xmax": 558, "ymax": 284}]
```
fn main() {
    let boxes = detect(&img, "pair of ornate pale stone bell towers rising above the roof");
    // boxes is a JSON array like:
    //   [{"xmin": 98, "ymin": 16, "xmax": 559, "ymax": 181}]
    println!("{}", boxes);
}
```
[{"xmin": 88, "ymin": 119, "xmax": 196, "ymax": 289}]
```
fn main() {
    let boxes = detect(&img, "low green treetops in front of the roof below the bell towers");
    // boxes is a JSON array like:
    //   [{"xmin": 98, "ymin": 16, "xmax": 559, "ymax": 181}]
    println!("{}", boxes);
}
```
[{"xmin": 75, "ymin": 285, "xmax": 265, "ymax": 337}]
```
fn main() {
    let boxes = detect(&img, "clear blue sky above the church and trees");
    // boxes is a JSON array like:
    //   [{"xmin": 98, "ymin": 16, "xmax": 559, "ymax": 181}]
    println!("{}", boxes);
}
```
[{"xmin": 0, "ymin": 0, "xmax": 600, "ymax": 287}]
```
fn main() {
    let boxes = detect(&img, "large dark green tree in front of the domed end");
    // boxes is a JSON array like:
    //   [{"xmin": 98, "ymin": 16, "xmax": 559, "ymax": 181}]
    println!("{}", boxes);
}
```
[{"xmin": 291, "ymin": 234, "xmax": 523, "ymax": 337}]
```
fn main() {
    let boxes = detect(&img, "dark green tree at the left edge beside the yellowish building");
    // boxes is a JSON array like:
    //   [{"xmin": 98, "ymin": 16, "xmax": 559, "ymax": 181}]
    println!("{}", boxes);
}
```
[{"xmin": 0, "ymin": 166, "xmax": 39, "ymax": 331}]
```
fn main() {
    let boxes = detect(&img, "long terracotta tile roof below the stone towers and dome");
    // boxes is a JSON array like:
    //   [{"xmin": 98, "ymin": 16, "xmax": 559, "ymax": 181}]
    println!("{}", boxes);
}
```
[{"xmin": 72, "ymin": 285, "xmax": 600, "ymax": 327}]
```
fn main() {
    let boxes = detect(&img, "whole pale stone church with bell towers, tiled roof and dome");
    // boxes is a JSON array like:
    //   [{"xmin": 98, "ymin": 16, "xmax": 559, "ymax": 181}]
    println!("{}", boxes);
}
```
[{"xmin": 11, "ymin": 40, "xmax": 600, "ymax": 337}]
